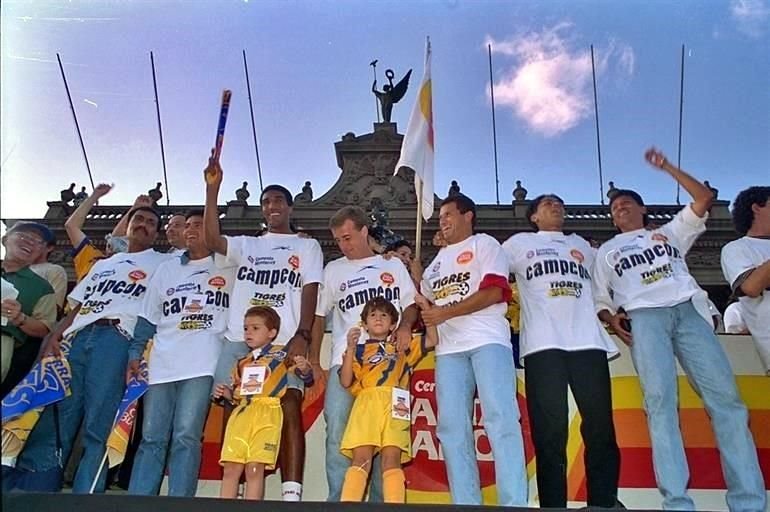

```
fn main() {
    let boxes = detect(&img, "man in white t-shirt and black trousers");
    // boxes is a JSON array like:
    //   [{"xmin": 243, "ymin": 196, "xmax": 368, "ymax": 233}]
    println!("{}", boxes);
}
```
[{"xmin": 503, "ymin": 194, "xmax": 620, "ymax": 508}]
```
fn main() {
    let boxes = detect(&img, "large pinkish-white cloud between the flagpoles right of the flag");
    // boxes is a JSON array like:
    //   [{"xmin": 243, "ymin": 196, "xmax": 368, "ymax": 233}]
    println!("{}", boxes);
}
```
[{"xmin": 485, "ymin": 22, "xmax": 635, "ymax": 137}]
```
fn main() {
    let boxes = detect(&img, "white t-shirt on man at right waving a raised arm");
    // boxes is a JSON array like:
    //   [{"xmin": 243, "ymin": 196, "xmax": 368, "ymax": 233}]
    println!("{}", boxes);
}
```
[{"xmin": 593, "ymin": 206, "xmax": 713, "ymax": 325}]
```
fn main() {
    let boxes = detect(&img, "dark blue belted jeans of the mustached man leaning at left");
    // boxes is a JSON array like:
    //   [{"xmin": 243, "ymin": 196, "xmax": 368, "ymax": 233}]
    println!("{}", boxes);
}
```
[{"xmin": 14, "ymin": 324, "xmax": 129, "ymax": 493}]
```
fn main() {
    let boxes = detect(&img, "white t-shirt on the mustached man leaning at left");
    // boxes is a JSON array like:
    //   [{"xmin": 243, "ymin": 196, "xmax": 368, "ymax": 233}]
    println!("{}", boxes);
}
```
[{"xmin": 64, "ymin": 249, "xmax": 173, "ymax": 336}]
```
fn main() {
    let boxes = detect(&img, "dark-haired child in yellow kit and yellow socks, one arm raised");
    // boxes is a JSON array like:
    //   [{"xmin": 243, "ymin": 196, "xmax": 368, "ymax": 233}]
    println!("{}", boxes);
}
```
[{"xmin": 340, "ymin": 297, "xmax": 436, "ymax": 503}]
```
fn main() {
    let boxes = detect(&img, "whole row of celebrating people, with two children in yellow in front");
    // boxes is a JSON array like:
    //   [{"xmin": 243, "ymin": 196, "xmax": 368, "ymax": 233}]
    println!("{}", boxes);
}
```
[{"xmin": 0, "ymin": 149, "xmax": 770, "ymax": 511}]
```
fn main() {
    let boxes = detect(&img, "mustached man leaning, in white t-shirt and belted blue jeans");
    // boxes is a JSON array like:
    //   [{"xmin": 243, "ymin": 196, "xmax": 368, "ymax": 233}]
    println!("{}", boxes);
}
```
[{"xmin": 17, "ymin": 207, "xmax": 169, "ymax": 493}]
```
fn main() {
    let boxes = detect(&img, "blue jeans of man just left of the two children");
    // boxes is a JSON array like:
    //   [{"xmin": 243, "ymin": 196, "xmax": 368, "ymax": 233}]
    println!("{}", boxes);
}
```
[{"xmin": 128, "ymin": 376, "xmax": 214, "ymax": 497}]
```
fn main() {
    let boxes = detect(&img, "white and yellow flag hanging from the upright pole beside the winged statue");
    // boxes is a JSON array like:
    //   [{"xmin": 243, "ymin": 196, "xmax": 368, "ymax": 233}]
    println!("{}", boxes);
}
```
[{"xmin": 396, "ymin": 38, "xmax": 434, "ymax": 220}]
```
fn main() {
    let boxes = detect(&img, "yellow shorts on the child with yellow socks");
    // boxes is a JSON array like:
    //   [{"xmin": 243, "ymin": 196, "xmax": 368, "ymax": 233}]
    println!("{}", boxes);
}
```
[{"xmin": 340, "ymin": 387, "xmax": 412, "ymax": 464}]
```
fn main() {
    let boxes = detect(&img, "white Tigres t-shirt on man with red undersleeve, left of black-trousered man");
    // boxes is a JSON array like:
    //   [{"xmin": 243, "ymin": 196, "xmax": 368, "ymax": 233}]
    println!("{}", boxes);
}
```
[{"xmin": 420, "ymin": 233, "xmax": 511, "ymax": 356}]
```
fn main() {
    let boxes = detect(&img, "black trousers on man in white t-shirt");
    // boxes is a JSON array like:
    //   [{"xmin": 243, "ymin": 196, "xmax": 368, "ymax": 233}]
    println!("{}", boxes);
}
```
[{"xmin": 524, "ymin": 349, "xmax": 620, "ymax": 508}]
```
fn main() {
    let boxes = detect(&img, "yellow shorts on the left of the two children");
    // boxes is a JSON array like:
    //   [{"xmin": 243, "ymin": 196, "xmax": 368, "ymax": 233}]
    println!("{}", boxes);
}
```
[{"xmin": 219, "ymin": 397, "xmax": 283, "ymax": 469}]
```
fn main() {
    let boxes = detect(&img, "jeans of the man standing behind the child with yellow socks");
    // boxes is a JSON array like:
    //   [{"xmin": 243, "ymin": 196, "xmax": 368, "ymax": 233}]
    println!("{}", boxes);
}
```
[{"xmin": 324, "ymin": 365, "xmax": 383, "ymax": 503}]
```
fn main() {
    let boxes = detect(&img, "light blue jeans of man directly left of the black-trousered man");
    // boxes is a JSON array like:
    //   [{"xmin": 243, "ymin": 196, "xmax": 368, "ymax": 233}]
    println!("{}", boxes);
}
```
[{"xmin": 436, "ymin": 344, "xmax": 528, "ymax": 506}]
